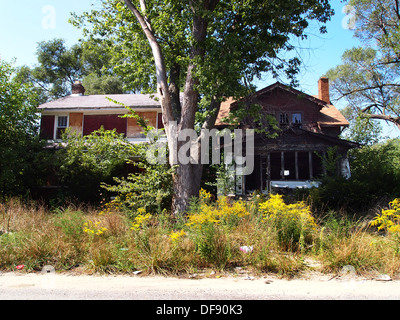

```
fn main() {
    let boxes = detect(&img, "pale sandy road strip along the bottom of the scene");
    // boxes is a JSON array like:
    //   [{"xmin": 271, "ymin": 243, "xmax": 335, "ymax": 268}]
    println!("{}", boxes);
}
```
[{"xmin": 0, "ymin": 272, "xmax": 400, "ymax": 300}]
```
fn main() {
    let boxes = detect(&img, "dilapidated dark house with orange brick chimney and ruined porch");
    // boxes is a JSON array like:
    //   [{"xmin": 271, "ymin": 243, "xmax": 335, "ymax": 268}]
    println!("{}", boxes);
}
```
[{"xmin": 216, "ymin": 78, "xmax": 358, "ymax": 194}]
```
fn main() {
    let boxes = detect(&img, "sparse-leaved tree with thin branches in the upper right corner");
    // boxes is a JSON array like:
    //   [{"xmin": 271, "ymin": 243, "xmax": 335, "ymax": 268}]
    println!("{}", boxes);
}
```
[{"xmin": 327, "ymin": 0, "xmax": 400, "ymax": 132}]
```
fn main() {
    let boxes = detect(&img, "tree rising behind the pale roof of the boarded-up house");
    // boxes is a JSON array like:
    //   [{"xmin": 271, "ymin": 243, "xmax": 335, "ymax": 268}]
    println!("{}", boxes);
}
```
[{"xmin": 17, "ymin": 39, "xmax": 123, "ymax": 103}]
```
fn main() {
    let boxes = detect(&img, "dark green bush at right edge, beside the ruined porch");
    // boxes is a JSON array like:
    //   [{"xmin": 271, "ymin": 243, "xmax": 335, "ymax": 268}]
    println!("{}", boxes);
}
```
[{"xmin": 302, "ymin": 139, "xmax": 400, "ymax": 215}]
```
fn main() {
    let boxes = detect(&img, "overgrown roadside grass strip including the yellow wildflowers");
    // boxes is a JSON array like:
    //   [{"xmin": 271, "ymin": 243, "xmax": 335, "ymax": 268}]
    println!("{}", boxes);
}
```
[{"xmin": 0, "ymin": 192, "xmax": 400, "ymax": 277}]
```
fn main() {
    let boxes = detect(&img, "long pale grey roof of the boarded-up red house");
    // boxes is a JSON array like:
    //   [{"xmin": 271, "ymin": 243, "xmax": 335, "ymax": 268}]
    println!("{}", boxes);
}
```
[{"xmin": 39, "ymin": 94, "xmax": 161, "ymax": 110}]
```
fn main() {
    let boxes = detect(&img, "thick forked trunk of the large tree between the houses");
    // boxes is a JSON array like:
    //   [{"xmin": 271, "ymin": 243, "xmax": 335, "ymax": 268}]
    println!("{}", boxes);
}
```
[{"xmin": 124, "ymin": 0, "xmax": 218, "ymax": 214}]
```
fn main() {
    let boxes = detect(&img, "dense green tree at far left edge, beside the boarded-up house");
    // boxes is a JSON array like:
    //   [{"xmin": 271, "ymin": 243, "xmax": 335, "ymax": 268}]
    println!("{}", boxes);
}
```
[{"xmin": 0, "ymin": 60, "xmax": 46, "ymax": 197}]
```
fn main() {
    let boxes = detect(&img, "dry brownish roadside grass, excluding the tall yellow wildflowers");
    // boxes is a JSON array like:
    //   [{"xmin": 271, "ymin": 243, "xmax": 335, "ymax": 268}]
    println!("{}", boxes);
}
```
[{"xmin": 0, "ymin": 200, "xmax": 400, "ymax": 278}]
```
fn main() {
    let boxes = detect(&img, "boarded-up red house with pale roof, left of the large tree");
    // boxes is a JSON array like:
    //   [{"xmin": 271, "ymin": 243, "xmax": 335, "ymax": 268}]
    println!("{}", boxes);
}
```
[{"xmin": 39, "ymin": 82, "xmax": 163, "ymax": 143}]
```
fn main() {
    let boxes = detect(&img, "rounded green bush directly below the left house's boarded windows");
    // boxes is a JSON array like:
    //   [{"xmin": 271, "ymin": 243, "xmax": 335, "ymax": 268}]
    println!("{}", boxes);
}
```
[{"xmin": 57, "ymin": 127, "xmax": 136, "ymax": 202}]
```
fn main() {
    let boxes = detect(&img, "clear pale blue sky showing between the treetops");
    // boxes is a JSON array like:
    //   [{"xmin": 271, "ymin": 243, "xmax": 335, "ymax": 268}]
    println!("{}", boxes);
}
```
[{"xmin": 0, "ymin": 0, "xmax": 400, "ymax": 136}]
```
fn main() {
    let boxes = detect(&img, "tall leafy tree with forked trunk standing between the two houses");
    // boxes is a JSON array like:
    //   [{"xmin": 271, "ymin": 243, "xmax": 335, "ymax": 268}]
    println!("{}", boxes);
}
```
[{"xmin": 72, "ymin": 0, "xmax": 333, "ymax": 212}]
